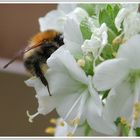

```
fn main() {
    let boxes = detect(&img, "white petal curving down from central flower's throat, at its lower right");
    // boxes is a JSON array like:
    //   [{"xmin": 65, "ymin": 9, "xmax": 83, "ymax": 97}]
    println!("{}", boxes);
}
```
[{"xmin": 86, "ymin": 77, "xmax": 116, "ymax": 135}]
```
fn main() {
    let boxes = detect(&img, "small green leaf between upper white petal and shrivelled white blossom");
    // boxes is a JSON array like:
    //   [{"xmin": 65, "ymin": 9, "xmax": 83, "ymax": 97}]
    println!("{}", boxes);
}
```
[{"xmin": 80, "ymin": 19, "xmax": 92, "ymax": 40}]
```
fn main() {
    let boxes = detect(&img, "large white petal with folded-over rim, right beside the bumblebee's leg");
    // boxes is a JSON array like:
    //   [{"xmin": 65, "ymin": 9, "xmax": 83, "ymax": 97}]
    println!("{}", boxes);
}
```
[{"xmin": 46, "ymin": 48, "xmax": 88, "ymax": 94}]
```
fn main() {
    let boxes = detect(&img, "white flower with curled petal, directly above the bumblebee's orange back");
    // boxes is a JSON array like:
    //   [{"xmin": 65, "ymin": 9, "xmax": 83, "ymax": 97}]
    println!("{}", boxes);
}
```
[{"xmin": 39, "ymin": 4, "xmax": 88, "ymax": 32}]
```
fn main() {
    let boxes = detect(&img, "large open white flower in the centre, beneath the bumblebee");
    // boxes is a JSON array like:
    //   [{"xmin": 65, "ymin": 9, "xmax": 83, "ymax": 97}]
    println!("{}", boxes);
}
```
[{"xmin": 26, "ymin": 47, "xmax": 112, "ymax": 134}]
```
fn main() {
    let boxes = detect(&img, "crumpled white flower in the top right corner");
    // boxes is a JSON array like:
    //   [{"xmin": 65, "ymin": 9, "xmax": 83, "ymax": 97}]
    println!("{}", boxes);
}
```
[{"xmin": 115, "ymin": 4, "xmax": 140, "ymax": 40}]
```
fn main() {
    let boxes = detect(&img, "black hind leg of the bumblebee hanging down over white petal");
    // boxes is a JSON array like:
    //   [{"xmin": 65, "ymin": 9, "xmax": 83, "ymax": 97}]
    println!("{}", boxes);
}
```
[{"xmin": 34, "ymin": 62, "xmax": 52, "ymax": 96}]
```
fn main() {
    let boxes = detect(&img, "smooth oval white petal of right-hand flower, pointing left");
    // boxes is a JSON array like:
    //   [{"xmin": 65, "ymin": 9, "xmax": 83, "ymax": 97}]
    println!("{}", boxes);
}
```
[{"xmin": 93, "ymin": 58, "xmax": 128, "ymax": 91}]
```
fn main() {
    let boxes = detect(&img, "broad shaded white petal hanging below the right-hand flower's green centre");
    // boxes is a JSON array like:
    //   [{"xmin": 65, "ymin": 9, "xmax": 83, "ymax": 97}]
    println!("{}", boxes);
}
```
[{"xmin": 103, "ymin": 81, "xmax": 134, "ymax": 123}]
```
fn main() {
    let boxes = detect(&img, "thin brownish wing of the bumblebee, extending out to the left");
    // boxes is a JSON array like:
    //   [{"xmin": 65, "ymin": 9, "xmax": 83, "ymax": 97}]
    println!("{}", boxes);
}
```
[{"xmin": 3, "ymin": 43, "xmax": 42, "ymax": 69}]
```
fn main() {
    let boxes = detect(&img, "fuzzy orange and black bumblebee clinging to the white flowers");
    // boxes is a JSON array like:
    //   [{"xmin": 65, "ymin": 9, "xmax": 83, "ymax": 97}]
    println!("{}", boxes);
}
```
[{"xmin": 4, "ymin": 30, "xmax": 64, "ymax": 96}]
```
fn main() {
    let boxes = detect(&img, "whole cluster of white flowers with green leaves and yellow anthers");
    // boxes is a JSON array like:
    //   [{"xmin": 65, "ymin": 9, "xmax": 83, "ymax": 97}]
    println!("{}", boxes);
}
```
[{"xmin": 25, "ymin": 4, "xmax": 140, "ymax": 136}]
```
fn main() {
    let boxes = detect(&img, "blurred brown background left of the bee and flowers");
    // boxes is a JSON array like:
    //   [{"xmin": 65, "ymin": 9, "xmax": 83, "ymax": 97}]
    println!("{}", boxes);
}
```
[{"xmin": 0, "ymin": 4, "xmax": 56, "ymax": 136}]
